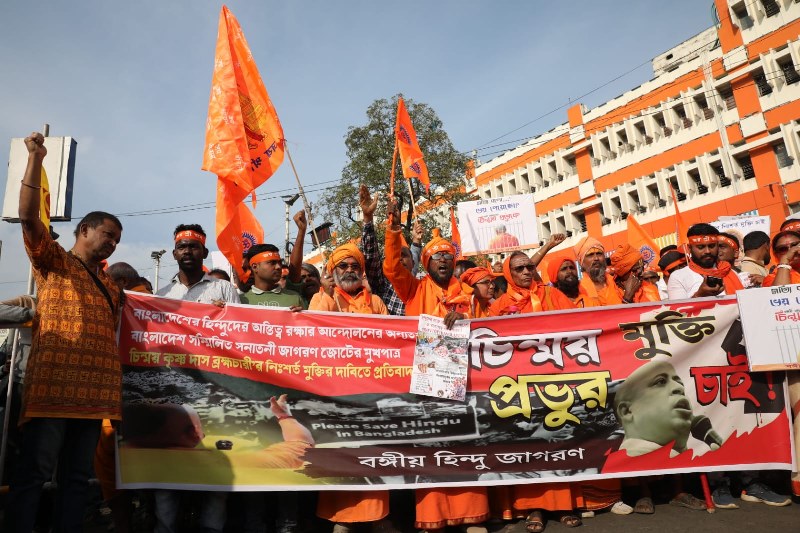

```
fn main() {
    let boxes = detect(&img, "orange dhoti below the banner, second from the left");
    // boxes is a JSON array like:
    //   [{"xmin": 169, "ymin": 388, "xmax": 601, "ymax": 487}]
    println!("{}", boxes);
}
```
[{"xmin": 414, "ymin": 487, "xmax": 489, "ymax": 529}]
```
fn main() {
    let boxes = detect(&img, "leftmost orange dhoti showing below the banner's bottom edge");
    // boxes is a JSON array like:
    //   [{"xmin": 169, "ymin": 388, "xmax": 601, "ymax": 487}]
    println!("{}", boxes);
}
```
[{"xmin": 317, "ymin": 490, "xmax": 389, "ymax": 523}]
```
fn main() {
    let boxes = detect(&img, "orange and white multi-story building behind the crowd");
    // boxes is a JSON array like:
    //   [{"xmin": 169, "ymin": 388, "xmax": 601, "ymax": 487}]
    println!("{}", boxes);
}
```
[{"xmin": 472, "ymin": 0, "xmax": 800, "ymax": 254}]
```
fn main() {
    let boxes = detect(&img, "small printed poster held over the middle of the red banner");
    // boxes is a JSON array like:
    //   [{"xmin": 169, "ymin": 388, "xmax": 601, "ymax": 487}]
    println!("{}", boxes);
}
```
[{"xmin": 410, "ymin": 315, "xmax": 469, "ymax": 401}]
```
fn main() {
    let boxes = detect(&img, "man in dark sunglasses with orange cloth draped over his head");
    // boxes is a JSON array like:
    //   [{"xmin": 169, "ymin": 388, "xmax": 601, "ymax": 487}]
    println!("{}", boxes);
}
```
[{"xmin": 489, "ymin": 252, "xmax": 575, "ymax": 316}]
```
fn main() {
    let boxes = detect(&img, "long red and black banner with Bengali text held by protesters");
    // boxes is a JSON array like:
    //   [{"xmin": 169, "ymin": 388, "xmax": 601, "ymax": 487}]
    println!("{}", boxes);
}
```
[{"xmin": 118, "ymin": 293, "xmax": 793, "ymax": 491}]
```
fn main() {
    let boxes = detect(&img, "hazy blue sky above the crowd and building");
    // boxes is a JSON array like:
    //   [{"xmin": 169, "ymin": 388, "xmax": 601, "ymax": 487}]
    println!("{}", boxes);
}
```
[{"xmin": 0, "ymin": 0, "xmax": 712, "ymax": 298}]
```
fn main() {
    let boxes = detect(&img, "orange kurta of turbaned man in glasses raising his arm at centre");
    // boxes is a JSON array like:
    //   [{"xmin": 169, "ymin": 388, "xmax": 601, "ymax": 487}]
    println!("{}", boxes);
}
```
[{"xmin": 383, "ymin": 229, "xmax": 470, "ymax": 317}]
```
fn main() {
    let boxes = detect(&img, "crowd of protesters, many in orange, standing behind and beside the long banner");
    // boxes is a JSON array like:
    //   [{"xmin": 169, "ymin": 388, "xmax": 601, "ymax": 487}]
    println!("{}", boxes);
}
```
[{"xmin": 3, "ymin": 134, "xmax": 800, "ymax": 533}]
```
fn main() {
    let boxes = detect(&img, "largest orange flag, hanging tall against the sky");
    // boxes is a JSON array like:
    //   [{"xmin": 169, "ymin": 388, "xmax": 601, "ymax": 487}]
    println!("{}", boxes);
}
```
[{"xmin": 202, "ymin": 6, "xmax": 284, "ymax": 276}]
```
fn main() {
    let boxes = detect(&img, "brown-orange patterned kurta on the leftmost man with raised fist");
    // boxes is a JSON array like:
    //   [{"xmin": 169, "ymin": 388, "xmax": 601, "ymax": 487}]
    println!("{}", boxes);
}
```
[{"xmin": 20, "ymin": 231, "xmax": 122, "ymax": 421}]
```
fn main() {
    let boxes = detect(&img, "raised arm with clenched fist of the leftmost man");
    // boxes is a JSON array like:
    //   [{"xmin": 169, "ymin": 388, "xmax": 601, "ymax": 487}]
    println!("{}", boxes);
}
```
[{"xmin": 19, "ymin": 132, "xmax": 47, "ymax": 246}]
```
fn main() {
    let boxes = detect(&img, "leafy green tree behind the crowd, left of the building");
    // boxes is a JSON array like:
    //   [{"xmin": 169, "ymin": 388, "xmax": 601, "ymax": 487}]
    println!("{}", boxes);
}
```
[{"xmin": 320, "ymin": 94, "xmax": 474, "ymax": 242}]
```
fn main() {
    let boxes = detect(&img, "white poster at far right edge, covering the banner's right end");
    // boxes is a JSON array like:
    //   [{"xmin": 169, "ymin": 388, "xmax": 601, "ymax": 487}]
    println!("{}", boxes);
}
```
[{"xmin": 736, "ymin": 285, "xmax": 800, "ymax": 372}]
